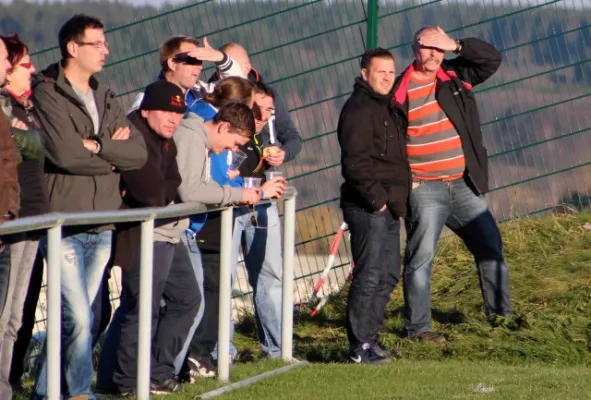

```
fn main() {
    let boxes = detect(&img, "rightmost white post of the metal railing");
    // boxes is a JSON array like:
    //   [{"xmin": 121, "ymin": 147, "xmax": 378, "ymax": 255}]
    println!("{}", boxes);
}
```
[{"xmin": 281, "ymin": 196, "xmax": 296, "ymax": 362}]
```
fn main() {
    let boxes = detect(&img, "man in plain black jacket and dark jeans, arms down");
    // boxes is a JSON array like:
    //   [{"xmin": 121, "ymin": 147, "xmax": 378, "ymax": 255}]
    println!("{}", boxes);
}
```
[{"xmin": 337, "ymin": 48, "xmax": 410, "ymax": 364}]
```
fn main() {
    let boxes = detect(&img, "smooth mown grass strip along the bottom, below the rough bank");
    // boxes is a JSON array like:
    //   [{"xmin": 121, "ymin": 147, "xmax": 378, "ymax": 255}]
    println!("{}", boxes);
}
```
[{"xmin": 218, "ymin": 360, "xmax": 591, "ymax": 400}]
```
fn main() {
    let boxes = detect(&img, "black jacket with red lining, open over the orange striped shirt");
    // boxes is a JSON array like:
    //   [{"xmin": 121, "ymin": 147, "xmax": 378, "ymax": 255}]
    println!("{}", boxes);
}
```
[{"xmin": 392, "ymin": 38, "xmax": 503, "ymax": 193}]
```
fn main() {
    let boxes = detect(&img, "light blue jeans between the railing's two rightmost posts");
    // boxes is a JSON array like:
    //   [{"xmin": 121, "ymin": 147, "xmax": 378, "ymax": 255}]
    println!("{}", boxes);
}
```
[{"xmin": 232, "ymin": 203, "xmax": 283, "ymax": 358}]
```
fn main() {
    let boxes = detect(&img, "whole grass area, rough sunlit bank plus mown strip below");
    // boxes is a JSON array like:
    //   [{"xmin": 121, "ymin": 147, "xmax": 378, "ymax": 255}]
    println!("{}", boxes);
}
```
[{"xmin": 16, "ymin": 212, "xmax": 591, "ymax": 400}]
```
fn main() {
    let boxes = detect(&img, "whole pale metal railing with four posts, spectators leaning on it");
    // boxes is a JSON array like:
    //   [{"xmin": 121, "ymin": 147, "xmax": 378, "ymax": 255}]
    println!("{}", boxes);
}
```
[{"xmin": 0, "ymin": 188, "xmax": 297, "ymax": 400}]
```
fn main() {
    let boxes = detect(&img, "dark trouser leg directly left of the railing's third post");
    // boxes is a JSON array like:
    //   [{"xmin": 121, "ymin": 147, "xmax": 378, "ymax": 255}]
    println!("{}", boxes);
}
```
[{"xmin": 188, "ymin": 250, "xmax": 220, "ymax": 362}]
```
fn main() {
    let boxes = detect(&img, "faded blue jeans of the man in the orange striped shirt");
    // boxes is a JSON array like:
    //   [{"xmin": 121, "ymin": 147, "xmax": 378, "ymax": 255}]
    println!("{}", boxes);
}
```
[{"xmin": 404, "ymin": 179, "xmax": 511, "ymax": 336}]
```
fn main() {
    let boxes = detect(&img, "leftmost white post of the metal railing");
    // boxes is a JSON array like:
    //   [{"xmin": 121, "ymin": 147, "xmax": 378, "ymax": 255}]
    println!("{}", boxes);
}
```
[{"xmin": 46, "ymin": 224, "xmax": 62, "ymax": 400}]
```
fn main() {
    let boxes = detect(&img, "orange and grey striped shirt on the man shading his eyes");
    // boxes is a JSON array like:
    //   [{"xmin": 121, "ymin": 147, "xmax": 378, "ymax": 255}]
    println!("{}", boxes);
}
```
[{"xmin": 406, "ymin": 78, "xmax": 466, "ymax": 181}]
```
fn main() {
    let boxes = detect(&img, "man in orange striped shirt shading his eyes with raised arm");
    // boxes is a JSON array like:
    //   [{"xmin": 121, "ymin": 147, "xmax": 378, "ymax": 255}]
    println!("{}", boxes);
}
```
[{"xmin": 393, "ymin": 27, "xmax": 511, "ymax": 342}]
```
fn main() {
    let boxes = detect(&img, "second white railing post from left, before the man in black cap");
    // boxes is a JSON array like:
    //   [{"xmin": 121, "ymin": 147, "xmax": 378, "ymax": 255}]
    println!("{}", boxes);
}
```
[{"xmin": 137, "ymin": 218, "xmax": 154, "ymax": 400}]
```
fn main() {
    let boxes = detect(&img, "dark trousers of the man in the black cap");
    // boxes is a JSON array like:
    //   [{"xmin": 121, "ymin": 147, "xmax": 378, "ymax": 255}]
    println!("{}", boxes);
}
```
[{"xmin": 113, "ymin": 242, "xmax": 201, "ymax": 389}]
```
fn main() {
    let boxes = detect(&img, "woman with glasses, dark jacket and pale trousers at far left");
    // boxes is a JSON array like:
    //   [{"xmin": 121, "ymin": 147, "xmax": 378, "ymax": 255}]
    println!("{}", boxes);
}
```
[{"xmin": 0, "ymin": 35, "xmax": 48, "ymax": 399}]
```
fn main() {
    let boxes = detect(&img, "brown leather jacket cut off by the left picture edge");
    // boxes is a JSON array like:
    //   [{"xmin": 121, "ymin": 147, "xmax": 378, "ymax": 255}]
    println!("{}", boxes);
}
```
[{"xmin": 0, "ymin": 112, "xmax": 19, "ymax": 223}]
